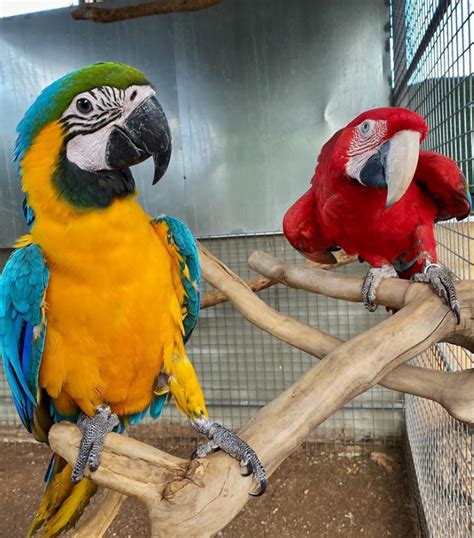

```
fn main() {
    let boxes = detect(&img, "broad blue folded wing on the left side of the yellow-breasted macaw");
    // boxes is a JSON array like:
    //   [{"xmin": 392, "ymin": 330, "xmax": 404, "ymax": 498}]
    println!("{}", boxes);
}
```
[{"xmin": 0, "ymin": 244, "xmax": 49, "ymax": 433}]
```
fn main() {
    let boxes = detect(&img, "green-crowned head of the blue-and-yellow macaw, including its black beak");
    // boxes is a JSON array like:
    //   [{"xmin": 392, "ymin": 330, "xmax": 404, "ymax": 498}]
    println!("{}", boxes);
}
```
[{"xmin": 15, "ymin": 62, "xmax": 171, "ymax": 208}]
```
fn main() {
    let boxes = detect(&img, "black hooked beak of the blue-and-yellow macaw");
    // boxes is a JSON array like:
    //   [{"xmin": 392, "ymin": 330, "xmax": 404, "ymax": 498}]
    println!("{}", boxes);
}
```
[{"xmin": 105, "ymin": 95, "xmax": 172, "ymax": 185}]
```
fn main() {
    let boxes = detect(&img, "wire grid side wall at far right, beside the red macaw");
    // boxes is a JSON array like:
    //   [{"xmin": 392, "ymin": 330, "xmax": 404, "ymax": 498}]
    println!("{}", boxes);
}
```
[{"xmin": 390, "ymin": 0, "xmax": 474, "ymax": 538}]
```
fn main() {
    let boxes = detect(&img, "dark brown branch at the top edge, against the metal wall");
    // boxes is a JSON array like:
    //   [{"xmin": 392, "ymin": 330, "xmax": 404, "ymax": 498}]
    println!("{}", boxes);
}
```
[{"xmin": 71, "ymin": 0, "xmax": 222, "ymax": 23}]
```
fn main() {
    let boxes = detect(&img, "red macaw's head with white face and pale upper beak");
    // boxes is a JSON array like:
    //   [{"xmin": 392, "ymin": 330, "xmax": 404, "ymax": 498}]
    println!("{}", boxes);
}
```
[{"xmin": 331, "ymin": 107, "xmax": 428, "ymax": 207}]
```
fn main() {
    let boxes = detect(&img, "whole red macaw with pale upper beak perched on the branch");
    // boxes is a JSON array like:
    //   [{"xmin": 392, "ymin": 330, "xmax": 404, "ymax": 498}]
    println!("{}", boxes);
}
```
[{"xmin": 283, "ymin": 107, "xmax": 471, "ymax": 316}]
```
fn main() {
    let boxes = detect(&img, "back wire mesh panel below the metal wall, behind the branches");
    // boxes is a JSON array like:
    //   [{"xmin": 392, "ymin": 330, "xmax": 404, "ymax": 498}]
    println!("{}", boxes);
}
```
[{"xmin": 0, "ymin": 234, "xmax": 403, "ymax": 444}]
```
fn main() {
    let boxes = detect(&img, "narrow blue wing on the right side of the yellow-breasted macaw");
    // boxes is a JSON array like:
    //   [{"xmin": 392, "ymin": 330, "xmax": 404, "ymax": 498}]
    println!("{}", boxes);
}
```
[{"xmin": 156, "ymin": 217, "xmax": 201, "ymax": 343}]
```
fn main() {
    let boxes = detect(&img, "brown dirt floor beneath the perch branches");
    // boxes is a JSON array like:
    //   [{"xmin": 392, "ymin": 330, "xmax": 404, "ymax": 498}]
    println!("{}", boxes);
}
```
[{"xmin": 0, "ymin": 442, "xmax": 418, "ymax": 538}]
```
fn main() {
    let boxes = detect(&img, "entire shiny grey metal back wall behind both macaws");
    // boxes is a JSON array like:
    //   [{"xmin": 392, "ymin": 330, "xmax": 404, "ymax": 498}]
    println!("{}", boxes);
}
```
[{"xmin": 0, "ymin": 0, "xmax": 388, "ymax": 246}]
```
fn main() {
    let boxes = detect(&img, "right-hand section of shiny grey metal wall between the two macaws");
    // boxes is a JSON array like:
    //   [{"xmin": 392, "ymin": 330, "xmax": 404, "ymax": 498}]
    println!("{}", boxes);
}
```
[{"xmin": 174, "ymin": 0, "xmax": 388, "ymax": 234}]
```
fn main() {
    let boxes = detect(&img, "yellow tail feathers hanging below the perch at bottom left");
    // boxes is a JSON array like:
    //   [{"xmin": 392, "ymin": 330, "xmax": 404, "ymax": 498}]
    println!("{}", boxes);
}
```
[{"xmin": 27, "ymin": 454, "xmax": 97, "ymax": 538}]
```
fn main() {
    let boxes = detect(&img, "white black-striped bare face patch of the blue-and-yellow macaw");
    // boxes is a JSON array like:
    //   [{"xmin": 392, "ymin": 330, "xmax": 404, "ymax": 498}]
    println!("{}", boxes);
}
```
[{"xmin": 62, "ymin": 85, "xmax": 155, "ymax": 172}]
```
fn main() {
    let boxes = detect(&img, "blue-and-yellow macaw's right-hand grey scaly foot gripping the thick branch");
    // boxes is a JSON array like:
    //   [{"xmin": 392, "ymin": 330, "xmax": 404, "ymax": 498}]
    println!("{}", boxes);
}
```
[{"xmin": 191, "ymin": 418, "xmax": 267, "ymax": 497}]
